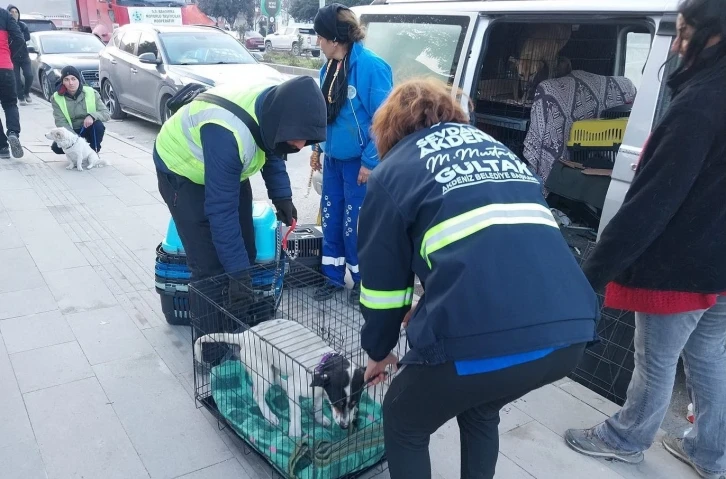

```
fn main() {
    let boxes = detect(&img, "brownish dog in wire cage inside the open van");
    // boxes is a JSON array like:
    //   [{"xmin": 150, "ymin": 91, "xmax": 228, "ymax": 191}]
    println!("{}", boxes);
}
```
[{"xmin": 509, "ymin": 24, "xmax": 572, "ymax": 102}]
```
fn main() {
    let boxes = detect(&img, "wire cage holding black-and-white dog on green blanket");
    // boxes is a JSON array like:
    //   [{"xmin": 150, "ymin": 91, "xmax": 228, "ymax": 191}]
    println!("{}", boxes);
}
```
[{"xmin": 190, "ymin": 265, "xmax": 406, "ymax": 479}]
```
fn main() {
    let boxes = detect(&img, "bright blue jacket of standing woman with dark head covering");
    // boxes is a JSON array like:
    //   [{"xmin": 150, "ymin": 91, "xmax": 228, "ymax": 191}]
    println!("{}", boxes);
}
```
[{"xmin": 320, "ymin": 43, "xmax": 393, "ymax": 170}]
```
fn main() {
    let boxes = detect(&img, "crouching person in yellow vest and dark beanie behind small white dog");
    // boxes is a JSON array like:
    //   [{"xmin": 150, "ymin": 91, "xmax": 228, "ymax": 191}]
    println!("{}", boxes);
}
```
[{"xmin": 50, "ymin": 66, "xmax": 111, "ymax": 155}]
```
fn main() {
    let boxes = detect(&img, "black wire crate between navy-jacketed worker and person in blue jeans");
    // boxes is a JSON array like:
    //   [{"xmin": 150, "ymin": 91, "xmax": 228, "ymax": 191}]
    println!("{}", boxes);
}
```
[{"xmin": 570, "ymin": 242, "xmax": 635, "ymax": 406}]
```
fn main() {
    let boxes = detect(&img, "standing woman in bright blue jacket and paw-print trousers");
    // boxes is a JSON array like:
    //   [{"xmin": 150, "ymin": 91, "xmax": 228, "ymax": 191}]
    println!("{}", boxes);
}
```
[{"xmin": 310, "ymin": 3, "xmax": 393, "ymax": 304}]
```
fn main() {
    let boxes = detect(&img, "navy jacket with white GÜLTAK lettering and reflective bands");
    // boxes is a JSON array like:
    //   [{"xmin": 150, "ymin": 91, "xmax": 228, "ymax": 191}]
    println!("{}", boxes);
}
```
[{"xmin": 358, "ymin": 123, "xmax": 599, "ymax": 366}]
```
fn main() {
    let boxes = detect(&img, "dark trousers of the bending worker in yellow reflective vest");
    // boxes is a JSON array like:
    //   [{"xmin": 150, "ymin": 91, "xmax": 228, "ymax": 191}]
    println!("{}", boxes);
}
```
[{"xmin": 156, "ymin": 170, "xmax": 257, "ymax": 281}]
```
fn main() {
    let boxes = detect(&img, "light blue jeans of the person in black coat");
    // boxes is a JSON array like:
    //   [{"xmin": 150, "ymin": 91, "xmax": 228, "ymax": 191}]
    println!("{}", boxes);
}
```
[{"xmin": 595, "ymin": 296, "xmax": 726, "ymax": 474}]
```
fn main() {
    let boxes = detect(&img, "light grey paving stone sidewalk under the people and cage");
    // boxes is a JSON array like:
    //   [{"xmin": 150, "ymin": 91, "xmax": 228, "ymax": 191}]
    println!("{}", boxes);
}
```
[{"xmin": 0, "ymin": 102, "xmax": 696, "ymax": 479}]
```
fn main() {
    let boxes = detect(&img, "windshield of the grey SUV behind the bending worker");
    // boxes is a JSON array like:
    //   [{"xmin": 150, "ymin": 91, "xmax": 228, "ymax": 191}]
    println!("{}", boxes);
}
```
[{"xmin": 159, "ymin": 32, "xmax": 257, "ymax": 65}]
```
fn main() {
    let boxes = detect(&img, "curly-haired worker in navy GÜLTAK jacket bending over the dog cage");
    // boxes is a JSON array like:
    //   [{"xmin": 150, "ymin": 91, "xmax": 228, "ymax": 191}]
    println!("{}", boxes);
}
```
[{"xmin": 358, "ymin": 79, "xmax": 598, "ymax": 479}]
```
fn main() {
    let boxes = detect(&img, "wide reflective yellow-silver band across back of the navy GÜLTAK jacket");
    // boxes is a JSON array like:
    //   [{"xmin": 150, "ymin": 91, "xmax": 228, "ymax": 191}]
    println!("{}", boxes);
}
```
[{"xmin": 420, "ymin": 203, "xmax": 559, "ymax": 268}]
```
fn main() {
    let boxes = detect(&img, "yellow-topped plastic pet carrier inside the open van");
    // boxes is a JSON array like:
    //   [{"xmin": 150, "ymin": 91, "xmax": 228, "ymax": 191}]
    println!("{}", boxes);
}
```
[{"xmin": 567, "ymin": 118, "xmax": 628, "ymax": 170}]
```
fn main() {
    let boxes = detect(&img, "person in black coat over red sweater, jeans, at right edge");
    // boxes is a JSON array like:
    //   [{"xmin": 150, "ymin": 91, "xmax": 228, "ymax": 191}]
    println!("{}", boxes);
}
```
[{"xmin": 565, "ymin": 0, "xmax": 726, "ymax": 479}]
